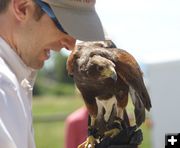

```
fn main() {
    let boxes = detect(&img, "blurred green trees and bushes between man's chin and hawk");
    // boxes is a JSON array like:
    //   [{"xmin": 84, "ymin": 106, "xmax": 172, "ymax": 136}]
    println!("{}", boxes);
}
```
[{"xmin": 33, "ymin": 54, "xmax": 74, "ymax": 95}]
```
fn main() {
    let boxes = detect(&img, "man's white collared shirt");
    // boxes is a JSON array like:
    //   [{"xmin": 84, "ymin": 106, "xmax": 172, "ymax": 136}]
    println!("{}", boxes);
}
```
[{"xmin": 0, "ymin": 37, "xmax": 36, "ymax": 148}]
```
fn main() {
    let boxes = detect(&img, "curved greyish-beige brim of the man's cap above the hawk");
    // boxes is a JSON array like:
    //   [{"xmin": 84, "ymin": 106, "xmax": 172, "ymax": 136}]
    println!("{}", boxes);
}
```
[{"xmin": 50, "ymin": 4, "xmax": 105, "ymax": 41}]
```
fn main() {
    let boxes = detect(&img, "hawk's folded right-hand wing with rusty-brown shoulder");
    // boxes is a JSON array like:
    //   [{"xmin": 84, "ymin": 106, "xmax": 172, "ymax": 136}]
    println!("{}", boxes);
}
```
[{"xmin": 115, "ymin": 50, "xmax": 151, "ymax": 126}]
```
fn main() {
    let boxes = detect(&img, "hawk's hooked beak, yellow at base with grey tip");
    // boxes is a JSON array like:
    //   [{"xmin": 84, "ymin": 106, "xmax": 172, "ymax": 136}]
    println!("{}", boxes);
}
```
[{"xmin": 101, "ymin": 67, "xmax": 117, "ymax": 81}]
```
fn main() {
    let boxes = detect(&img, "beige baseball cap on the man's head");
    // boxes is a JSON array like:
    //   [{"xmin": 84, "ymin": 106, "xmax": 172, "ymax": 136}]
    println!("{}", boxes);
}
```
[{"xmin": 42, "ymin": 0, "xmax": 104, "ymax": 41}]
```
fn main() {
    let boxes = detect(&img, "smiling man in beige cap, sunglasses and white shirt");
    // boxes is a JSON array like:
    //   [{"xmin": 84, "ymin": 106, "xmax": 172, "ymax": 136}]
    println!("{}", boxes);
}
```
[{"xmin": 0, "ymin": 0, "xmax": 104, "ymax": 148}]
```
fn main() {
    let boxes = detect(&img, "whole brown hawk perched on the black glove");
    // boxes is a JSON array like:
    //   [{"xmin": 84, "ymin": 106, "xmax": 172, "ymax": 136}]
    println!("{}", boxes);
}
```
[{"xmin": 67, "ymin": 40, "xmax": 151, "ymax": 148}]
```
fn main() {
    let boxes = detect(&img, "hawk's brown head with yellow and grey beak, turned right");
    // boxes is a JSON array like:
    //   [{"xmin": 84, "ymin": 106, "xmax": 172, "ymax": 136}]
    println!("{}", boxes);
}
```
[{"xmin": 85, "ymin": 55, "xmax": 117, "ymax": 81}]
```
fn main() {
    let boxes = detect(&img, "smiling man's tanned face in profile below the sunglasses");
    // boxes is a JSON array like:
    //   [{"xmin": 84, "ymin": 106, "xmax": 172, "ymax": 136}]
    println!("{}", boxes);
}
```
[{"xmin": 17, "ymin": 2, "xmax": 75, "ymax": 69}]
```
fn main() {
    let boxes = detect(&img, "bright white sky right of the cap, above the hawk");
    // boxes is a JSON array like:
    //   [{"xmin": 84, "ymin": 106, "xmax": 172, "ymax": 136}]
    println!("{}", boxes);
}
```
[{"xmin": 96, "ymin": 0, "xmax": 180, "ymax": 62}]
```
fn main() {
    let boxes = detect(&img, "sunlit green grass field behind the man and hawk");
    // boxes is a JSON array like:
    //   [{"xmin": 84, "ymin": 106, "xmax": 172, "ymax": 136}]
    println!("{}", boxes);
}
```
[{"xmin": 33, "ymin": 96, "xmax": 151, "ymax": 148}]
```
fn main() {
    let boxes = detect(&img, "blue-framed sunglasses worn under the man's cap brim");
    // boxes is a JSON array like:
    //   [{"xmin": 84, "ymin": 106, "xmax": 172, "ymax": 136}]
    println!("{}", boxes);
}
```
[{"xmin": 36, "ymin": 0, "xmax": 68, "ymax": 34}]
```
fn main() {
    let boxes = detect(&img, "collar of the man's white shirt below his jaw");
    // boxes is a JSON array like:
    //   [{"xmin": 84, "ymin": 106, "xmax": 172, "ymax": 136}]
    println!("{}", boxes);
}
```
[{"xmin": 0, "ymin": 37, "xmax": 37, "ymax": 86}]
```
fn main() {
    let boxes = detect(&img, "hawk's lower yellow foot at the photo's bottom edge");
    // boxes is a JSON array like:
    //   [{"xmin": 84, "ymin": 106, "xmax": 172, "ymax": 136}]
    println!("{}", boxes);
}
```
[{"xmin": 78, "ymin": 136, "xmax": 96, "ymax": 148}]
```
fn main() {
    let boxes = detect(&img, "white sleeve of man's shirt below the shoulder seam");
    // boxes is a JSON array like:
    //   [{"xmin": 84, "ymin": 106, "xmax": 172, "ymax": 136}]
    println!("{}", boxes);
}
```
[{"xmin": 0, "ymin": 75, "xmax": 27, "ymax": 148}]
